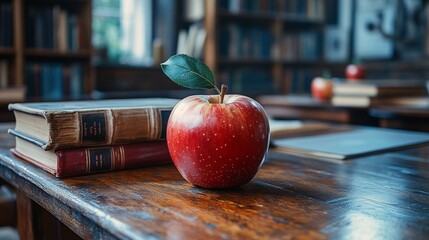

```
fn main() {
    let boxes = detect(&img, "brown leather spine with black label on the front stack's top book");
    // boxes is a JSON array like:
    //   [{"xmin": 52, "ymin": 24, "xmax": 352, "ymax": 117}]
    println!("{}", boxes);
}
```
[{"xmin": 43, "ymin": 107, "xmax": 172, "ymax": 150}]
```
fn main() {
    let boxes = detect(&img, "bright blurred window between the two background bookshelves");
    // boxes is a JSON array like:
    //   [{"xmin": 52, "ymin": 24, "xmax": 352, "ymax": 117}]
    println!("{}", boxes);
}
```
[{"xmin": 92, "ymin": 0, "xmax": 152, "ymax": 65}]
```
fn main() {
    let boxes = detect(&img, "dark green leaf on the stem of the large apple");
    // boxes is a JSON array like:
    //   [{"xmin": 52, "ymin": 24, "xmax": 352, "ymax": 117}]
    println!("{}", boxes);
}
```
[{"xmin": 161, "ymin": 54, "xmax": 219, "ymax": 92}]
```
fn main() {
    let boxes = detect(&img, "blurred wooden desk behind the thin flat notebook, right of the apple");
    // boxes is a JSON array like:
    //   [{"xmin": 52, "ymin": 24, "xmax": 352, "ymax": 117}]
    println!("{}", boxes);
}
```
[{"xmin": 258, "ymin": 95, "xmax": 377, "ymax": 126}]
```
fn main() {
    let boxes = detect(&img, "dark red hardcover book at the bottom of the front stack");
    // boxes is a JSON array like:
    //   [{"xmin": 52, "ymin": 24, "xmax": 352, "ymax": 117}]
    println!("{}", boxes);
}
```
[{"xmin": 9, "ymin": 130, "xmax": 172, "ymax": 177}]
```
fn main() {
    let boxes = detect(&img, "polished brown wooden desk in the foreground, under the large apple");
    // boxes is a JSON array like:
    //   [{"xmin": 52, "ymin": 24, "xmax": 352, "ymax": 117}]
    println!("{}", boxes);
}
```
[{"xmin": 0, "ymin": 124, "xmax": 429, "ymax": 239}]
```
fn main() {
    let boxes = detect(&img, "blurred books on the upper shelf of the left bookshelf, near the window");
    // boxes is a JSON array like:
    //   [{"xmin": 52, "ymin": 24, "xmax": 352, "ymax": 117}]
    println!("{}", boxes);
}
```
[{"xmin": 24, "ymin": 5, "xmax": 83, "ymax": 51}]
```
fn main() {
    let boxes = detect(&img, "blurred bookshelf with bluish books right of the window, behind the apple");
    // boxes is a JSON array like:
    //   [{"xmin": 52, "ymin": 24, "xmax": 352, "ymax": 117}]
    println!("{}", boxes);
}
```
[{"xmin": 204, "ymin": 0, "xmax": 342, "ymax": 96}]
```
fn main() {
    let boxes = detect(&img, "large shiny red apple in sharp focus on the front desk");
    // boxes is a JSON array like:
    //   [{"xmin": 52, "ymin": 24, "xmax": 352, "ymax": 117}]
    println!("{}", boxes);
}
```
[{"xmin": 167, "ymin": 95, "xmax": 270, "ymax": 188}]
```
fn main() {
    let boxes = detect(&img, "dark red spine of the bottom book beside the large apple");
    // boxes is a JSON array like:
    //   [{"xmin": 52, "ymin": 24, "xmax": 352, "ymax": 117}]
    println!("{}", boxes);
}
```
[{"xmin": 55, "ymin": 141, "xmax": 171, "ymax": 177}]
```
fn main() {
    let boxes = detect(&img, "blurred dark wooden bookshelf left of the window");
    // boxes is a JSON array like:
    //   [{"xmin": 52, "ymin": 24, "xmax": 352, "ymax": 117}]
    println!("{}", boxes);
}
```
[{"xmin": 0, "ymin": 0, "xmax": 93, "ymax": 105}]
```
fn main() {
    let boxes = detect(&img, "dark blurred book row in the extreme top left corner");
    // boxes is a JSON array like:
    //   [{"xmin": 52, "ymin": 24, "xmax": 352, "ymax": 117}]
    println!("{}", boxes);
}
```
[{"xmin": 0, "ymin": 2, "xmax": 13, "ymax": 47}]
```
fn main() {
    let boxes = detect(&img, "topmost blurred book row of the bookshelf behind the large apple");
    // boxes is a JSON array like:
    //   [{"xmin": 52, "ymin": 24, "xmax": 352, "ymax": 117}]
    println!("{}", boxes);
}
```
[{"xmin": 220, "ymin": 0, "xmax": 324, "ymax": 20}]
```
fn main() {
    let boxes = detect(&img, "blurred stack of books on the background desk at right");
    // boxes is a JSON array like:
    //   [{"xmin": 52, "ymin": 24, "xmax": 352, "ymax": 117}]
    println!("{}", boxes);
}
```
[{"xmin": 332, "ymin": 80, "xmax": 428, "ymax": 107}]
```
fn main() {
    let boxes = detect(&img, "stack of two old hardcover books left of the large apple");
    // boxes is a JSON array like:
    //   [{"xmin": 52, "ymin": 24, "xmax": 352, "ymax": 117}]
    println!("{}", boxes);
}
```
[{"xmin": 9, "ymin": 98, "xmax": 178, "ymax": 177}]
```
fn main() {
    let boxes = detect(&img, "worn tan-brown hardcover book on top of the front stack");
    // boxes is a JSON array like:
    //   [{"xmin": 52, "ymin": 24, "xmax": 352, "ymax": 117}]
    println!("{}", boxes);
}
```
[{"xmin": 9, "ymin": 98, "xmax": 179, "ymax": 150}]
